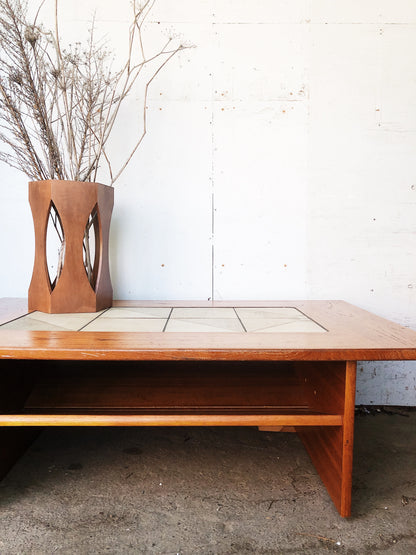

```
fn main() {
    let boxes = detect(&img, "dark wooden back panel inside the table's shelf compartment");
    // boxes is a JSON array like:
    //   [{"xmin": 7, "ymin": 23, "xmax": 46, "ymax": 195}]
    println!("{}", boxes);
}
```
[{"xmin": 25, "ymin": 361, "xmax": 308, "ymax": 412}]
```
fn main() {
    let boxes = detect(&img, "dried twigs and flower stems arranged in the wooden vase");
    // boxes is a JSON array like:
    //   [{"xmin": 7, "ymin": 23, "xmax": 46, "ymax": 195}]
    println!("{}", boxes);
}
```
[{"xmin": 0, "ymin": 0, "xmax": 187, "ymax": 300}]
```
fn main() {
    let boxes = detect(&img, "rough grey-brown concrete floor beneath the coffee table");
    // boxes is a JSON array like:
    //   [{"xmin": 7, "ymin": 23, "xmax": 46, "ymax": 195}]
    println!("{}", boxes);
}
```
[{"xmin": 0, "ymin": 410, "xmax": 416, "ymax": 555}]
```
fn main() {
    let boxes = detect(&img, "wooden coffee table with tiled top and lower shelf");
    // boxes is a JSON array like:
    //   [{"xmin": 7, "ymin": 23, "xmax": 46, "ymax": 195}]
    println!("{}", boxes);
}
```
[{"xmin": 0, "ymin": 299, "xmax": 416, "ymax": 517}]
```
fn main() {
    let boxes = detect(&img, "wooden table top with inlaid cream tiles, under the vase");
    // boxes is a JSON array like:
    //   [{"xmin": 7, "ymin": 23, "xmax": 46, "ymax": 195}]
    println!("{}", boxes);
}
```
[{"xmin": 0, "ymin": 299, "xmax": 416, "ymax": 361}]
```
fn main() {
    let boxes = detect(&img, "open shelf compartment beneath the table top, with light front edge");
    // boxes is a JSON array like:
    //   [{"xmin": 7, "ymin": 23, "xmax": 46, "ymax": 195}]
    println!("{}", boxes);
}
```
[{"xmin": 0, "ymin": 361, "xmax": 345, "ymax": 428}]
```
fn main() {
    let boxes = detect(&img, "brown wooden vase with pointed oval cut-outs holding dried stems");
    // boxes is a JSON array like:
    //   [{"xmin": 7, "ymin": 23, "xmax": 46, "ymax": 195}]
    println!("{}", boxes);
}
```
[{"xmin": 28, "ymin": 180, "xmax": 114, "ymax": 313}]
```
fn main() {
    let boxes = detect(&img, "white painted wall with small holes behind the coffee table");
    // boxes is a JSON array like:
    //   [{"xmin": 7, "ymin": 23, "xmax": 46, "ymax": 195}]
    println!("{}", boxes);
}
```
[{"xmin": 0, "ymin": 0, "xmax": 416, "ymax": 405}]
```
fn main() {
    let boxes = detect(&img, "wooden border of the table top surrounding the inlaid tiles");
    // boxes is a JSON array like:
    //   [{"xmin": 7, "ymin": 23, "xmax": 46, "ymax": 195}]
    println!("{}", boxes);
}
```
[{"xmin": 0, "ymin": 301, "xmax": 416, "ymax": 361}]
